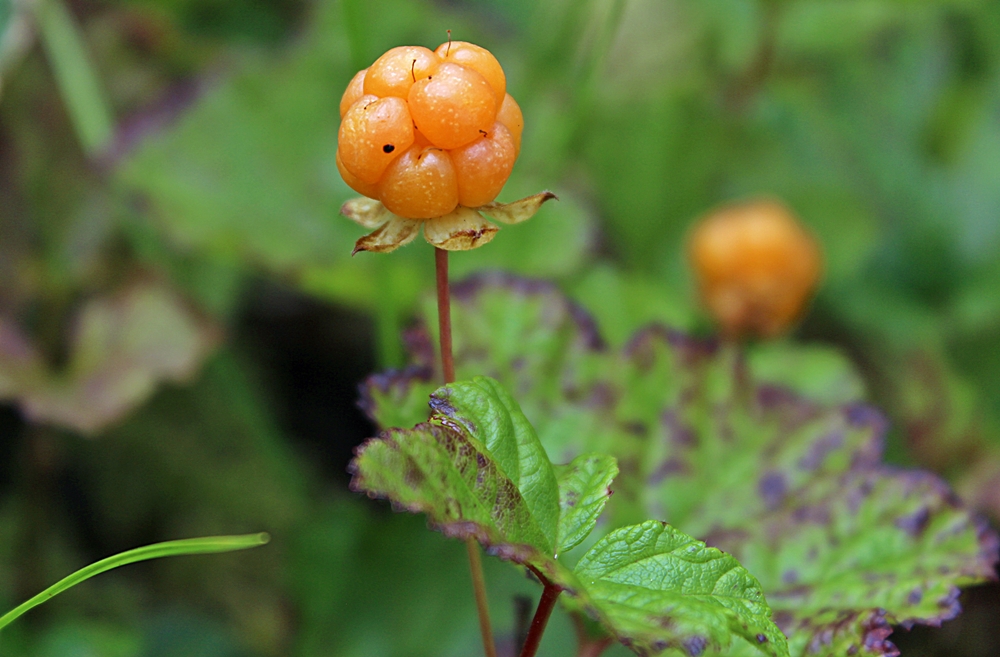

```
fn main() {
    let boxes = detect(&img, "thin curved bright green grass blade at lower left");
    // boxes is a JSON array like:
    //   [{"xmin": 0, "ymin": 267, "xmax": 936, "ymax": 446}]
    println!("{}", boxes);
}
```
[{"xmin": 0, "ymin": 534, "xmax": 271, "ymax": 630}]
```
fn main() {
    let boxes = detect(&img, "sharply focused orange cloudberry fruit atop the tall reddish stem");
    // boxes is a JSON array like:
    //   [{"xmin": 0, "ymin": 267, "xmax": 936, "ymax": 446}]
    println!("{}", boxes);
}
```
[{"xmin": 337, "ymin": 41, "xmax": 524, "ymax": 220}]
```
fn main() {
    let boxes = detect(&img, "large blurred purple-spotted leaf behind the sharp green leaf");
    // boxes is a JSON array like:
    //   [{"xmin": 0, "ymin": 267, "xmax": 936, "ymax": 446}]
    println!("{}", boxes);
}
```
[{"xmin": 365, "ymin": 275, "xmax": 997, "ymax": 657}]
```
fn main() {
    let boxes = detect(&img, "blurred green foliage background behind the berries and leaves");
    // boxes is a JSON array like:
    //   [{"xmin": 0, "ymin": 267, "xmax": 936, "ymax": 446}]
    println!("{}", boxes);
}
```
[{"xmin": 0, "ymin": 0, "xmax": 1000, "ymax": 657}]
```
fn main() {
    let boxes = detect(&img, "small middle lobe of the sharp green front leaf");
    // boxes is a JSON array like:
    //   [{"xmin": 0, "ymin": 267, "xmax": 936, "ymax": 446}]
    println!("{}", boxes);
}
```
[{"xmin": 555, "ymin": 453, "xmax": 618, "ymax": 553}]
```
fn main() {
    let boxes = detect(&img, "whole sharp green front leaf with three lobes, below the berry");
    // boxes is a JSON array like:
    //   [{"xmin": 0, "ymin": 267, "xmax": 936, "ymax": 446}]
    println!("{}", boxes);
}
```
[{"xmin": 351, "ymin": 377, "xmax": 787, "ymax": 655}]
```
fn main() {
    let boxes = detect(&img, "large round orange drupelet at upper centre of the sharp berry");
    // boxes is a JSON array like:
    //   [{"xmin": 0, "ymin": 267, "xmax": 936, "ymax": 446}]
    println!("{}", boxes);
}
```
[{"xmin": 408, "ymin": 62, "xmax": 497, "ymax": 149}]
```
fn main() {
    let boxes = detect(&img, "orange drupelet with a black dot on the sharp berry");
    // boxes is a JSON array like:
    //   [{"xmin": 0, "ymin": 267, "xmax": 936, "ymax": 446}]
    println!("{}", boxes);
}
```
[{"xmin": 338, "ymin": 95, "xmax": 413, "ymax": 185}]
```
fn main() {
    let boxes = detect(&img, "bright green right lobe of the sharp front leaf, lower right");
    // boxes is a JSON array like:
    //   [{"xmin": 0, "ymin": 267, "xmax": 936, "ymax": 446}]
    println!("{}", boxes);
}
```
[{"xmin": 575, "ymin": 520, "xmax": 788, "ymax": 655}]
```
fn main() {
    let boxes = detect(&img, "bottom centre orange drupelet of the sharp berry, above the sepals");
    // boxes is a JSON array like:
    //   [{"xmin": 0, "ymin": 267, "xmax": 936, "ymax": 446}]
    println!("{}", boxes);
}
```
[{"xmin": 378, "ymin": 145, "xmax": 458, "ymax": 219}]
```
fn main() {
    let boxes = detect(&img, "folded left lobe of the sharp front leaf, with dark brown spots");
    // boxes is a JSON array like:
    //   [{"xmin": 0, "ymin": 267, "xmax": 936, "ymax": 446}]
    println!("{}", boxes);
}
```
[{"xmin": 351, "ymin": 377, "xmax": 560, "ymax": 569}]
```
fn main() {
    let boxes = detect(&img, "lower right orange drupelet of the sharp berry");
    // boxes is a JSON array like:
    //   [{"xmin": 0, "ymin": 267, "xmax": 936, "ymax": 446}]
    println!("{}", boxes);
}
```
[{"xmin": 451, "ymin": 121, "xmax": 517, "ymax": 208}]
